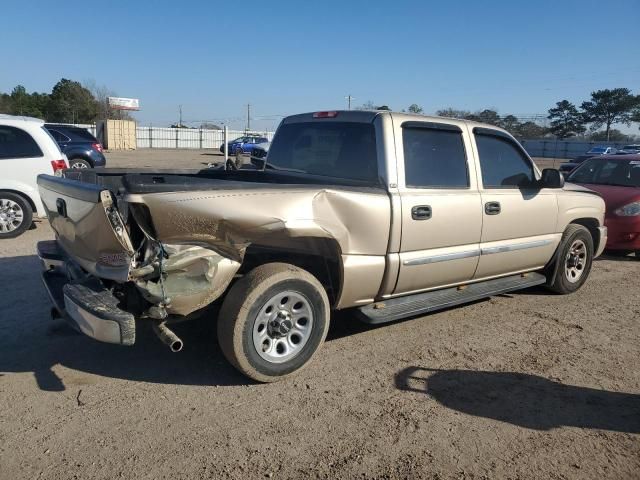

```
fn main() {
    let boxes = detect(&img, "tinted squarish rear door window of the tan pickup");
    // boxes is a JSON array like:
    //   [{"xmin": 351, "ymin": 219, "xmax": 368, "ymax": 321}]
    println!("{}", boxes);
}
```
[{"xmin": 402, "ymin": 125, "xmax": 469, "ymax": 188}]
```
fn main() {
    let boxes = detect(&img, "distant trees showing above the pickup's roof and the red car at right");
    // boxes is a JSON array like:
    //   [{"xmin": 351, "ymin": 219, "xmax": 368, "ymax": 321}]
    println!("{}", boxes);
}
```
[{"xmin": 359, "ymin": 88, "xmax": 640, "ymax": 141}]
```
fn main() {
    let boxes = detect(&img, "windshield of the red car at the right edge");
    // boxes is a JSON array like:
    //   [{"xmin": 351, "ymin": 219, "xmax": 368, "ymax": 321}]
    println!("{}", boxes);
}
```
[{"xmin": 568, "ymin": 158, "xmax": 640, "ymax": 187}]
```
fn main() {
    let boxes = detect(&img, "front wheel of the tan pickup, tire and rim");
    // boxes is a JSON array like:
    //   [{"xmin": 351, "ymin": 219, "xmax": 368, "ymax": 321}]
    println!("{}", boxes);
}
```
[{"xmin": 549, "ymin": 224, "xmax": 593, "ymax": 295}]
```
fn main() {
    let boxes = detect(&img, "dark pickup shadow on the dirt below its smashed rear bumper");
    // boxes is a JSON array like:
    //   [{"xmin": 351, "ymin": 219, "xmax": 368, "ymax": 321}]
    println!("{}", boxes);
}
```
[{"xmin": 0, "ymin": 255, "xmax": 372, "ymax": 391}]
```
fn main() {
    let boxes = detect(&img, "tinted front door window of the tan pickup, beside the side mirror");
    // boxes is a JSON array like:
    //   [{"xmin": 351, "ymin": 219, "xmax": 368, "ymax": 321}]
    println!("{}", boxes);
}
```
[{"xmin": 475, "ymin": 131, "xmax": 535, "ymax": 188}]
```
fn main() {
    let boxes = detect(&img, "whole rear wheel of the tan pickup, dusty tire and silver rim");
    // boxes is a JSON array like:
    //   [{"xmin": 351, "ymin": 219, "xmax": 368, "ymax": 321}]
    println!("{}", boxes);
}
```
[{"xmin": 218, "ymin": 263, "xmax": 330, "ymax": 382}]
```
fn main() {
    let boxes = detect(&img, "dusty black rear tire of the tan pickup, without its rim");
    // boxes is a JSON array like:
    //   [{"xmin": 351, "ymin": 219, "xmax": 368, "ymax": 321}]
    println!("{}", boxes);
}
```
[{"xmin": 218, "ymin": 263, "xmax": 330, "ymax": 382}]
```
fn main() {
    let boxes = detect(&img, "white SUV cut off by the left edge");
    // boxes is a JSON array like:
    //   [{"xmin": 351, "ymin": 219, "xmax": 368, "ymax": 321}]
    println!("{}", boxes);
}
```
[{"xmin": 0, "ymin": 114, "xmax": 67, "ymax": 239}]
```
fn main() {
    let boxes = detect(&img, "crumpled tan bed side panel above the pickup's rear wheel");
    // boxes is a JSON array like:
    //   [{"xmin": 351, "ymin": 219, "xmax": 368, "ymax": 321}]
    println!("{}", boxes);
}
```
[{"xmin": 126, "ymin": 186, "xmax": 391, "ymax": 314}]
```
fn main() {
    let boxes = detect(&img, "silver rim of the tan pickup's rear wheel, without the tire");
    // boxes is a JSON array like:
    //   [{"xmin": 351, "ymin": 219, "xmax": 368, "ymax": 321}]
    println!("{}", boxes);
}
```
[{"xmin": 253, "ymin": 290, "xmax": 313, "ymax": 363}]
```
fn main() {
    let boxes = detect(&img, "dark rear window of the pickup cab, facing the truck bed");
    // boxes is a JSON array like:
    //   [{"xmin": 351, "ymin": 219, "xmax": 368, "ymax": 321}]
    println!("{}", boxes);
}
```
[{"xmin": 269, "ymin": 121, "xmax": 378, "ymax": 183}]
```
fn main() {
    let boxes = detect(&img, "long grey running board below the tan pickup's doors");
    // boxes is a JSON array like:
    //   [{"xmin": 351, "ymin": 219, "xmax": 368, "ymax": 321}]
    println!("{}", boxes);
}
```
[{"xmin": 357, "ymin": 272, "xmax": 547, "ymax": 324}]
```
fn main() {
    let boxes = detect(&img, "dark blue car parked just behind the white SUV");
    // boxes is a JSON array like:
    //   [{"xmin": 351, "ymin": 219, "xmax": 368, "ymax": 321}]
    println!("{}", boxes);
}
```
[{"xmin": 44, "ymin": 123, "xmax": 107, "ymax": 168}]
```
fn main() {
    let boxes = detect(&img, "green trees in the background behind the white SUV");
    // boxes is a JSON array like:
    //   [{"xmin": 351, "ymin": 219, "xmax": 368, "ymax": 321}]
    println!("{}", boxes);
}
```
[{"xmin": 0, "ymin": 78, "xmax": 130, "ymax": 123}]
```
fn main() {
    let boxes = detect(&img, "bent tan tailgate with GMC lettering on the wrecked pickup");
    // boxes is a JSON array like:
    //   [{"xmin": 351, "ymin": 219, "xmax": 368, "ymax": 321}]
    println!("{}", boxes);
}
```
[{"xmin": 38, "ymin": 175, "xmax": 133, "ymax": 282}]
